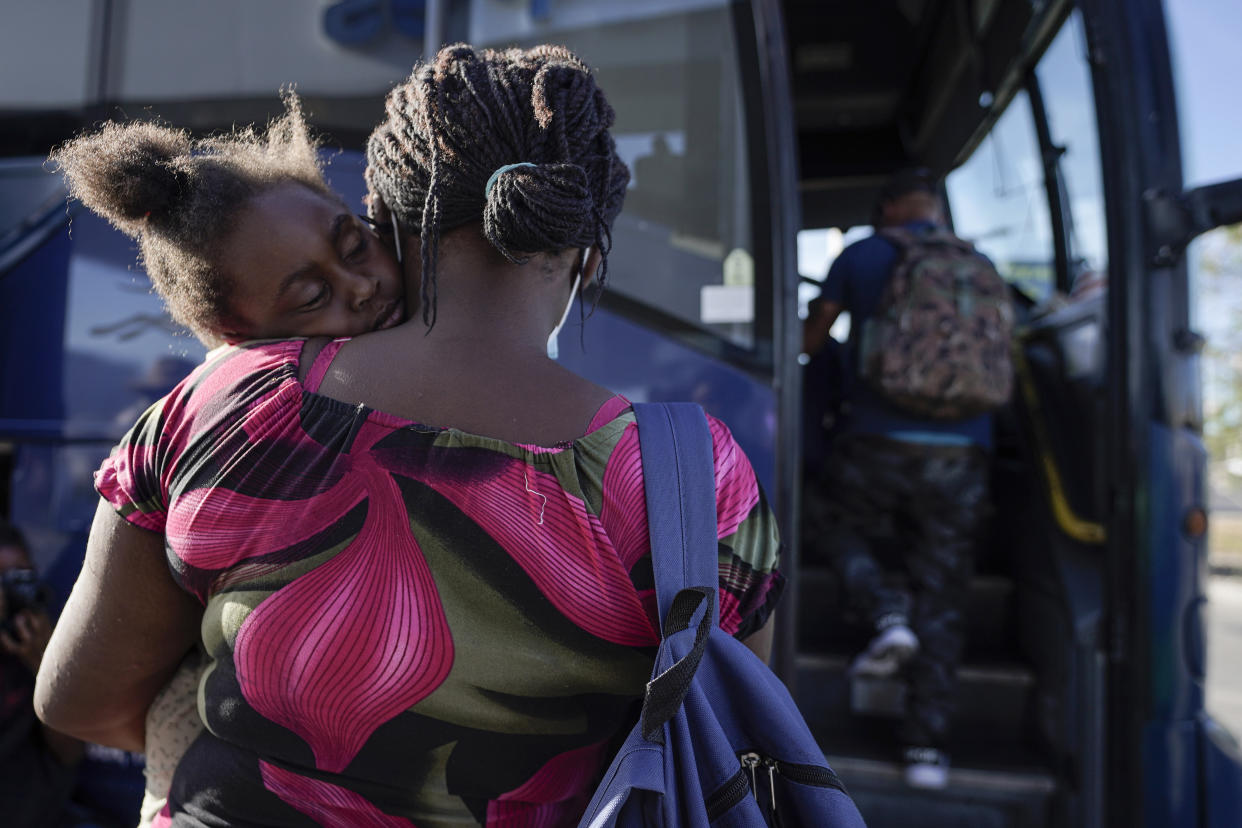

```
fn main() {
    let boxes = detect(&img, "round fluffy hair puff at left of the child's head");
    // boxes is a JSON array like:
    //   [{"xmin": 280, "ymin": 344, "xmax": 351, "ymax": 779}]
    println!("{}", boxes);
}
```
[{"xmin": 51, "ymin": 123, "xmax": 193, "ymax": 236}]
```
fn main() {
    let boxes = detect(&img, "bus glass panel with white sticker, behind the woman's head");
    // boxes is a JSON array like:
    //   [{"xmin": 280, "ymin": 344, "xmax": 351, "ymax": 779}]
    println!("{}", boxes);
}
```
[{"xmin": 471, "ymin": 0, "xmax": 750, "ymax": 349}]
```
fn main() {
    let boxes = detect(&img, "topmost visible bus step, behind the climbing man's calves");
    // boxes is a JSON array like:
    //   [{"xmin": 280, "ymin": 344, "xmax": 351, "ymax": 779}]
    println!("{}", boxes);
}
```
[{"xmin": 797, "ymin": 567, "xmax": 1018, "ymax": 659}]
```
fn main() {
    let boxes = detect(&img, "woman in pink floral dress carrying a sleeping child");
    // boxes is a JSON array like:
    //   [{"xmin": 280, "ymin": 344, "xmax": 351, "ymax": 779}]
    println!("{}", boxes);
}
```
[{"xmin": 37, "ymin": 45, "xmax": 781, "ymax": 828}]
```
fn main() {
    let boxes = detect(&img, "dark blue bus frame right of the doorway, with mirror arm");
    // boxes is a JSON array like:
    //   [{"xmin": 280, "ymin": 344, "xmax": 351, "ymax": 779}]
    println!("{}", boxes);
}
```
[{"xmin": 1081, "ymin": 0, "xmax": 1242, "ymax": 826}]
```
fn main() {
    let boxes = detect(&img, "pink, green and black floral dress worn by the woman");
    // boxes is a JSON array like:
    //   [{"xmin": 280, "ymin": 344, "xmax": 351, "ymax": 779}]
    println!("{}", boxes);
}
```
[{"xmin": 97, "ymin": 340, "xmax": 782, "ymax": 828}]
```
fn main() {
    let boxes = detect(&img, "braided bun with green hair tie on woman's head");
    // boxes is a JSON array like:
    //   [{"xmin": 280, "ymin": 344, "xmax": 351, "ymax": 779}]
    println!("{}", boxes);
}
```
[{"xmin": 483, "ymin": 164, "xmax": 596, "ymax": 264}]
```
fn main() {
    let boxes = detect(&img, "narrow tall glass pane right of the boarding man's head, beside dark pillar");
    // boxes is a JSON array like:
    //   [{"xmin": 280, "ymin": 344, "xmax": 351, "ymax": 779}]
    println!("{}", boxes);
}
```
[{"xmin": 1035, "ymin": 11, "xmax": 1108, "ymax": 286}]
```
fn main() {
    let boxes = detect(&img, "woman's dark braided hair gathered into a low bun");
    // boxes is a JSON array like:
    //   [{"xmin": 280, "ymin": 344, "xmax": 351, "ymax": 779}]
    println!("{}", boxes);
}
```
[{"xmin": 366, "ymin": 43, "xmax": 630, "ymax": 325}]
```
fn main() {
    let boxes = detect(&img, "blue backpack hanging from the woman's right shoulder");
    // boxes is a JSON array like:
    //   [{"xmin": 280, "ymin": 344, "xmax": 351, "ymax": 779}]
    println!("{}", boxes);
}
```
[{"xmin": 579, "ymin": 403, "xmax": 863, "ymax": 828}]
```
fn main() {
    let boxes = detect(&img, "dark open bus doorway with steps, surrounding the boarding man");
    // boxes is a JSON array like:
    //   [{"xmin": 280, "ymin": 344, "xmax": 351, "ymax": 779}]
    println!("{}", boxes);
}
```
[{"xmin": 789, "ymin": 4, "xmax": 1104, "ymax": 828}]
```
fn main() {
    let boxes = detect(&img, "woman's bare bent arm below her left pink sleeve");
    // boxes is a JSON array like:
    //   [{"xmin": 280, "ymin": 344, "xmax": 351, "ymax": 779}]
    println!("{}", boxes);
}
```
[{"xmin": 35, "ymin": 500, "xmax": 202, "ymax": 751}]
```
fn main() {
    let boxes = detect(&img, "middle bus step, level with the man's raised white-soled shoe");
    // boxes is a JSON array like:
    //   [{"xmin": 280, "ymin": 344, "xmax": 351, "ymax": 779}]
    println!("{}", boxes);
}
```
[{"xmin": 795, "ymin": 654, "xmax": 1035, "ymax": 744}]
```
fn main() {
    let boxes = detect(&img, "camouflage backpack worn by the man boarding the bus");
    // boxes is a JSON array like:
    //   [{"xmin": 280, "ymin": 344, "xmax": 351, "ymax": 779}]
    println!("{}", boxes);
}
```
[{"xmin": 858, "ymin": 228, "xmax": 1013, "ymax": 420}]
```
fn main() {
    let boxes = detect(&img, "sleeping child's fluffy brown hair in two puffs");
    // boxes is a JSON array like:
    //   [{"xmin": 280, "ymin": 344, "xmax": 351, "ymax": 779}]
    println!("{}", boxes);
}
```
[{"xmin": 50, "ymin": 94, "xmax": 337, "ymax": 343}]
